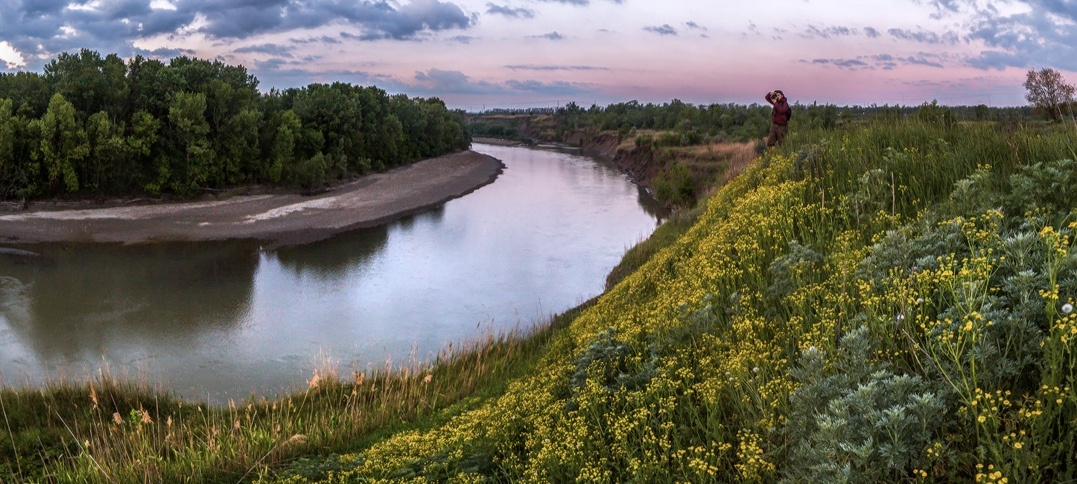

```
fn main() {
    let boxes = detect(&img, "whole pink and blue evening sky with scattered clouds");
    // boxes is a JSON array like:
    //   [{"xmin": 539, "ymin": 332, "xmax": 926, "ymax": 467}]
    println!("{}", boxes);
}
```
[{"xmin": 0, "ymin": 0, "xmax": 1077, "ymax": 111}]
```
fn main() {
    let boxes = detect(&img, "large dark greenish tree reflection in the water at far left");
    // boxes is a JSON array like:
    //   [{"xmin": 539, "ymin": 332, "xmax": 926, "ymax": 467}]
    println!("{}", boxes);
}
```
[{"xmin": 0, "ymin": 243, "xmax": 258, "ymax": 376}]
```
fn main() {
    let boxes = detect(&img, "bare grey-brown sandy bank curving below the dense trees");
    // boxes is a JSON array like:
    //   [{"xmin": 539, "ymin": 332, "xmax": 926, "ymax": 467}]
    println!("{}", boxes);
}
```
[{"xmin": 0, "ymin": 151, "xmax": 504, "ymax": 245}]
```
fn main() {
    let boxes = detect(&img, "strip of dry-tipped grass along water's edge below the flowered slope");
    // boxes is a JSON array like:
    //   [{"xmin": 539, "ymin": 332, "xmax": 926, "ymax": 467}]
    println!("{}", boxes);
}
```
[{"xmin": 0, "ymin": 303, "xmax": 589, "ymax": 482}]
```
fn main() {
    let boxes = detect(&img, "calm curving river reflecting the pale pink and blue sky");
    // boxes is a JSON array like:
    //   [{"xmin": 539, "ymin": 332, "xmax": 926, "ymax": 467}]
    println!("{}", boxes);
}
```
[{"xmin": 0, "ymin": 144, "xmax": 663, "ymax": 404}]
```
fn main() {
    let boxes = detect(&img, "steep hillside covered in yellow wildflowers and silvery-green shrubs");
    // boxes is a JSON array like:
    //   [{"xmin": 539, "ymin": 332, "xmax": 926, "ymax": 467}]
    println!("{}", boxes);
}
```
[{"xmin": 273, "ymin": 120, "xmax": 1077, "ymax": 482}]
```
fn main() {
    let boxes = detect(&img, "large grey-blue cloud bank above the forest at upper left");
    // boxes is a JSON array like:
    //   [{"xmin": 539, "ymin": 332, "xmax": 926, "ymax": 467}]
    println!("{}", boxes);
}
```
[{"xmin": 0, "ymin": 0, "xmax": 478, "ymax": 70}]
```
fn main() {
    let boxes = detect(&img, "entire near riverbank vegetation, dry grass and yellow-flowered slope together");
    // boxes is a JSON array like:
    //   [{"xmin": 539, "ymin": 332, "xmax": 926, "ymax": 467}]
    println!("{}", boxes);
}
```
[{"xmin": 0, "ymin": 105, "xmax": 1077, "ymax": 483}]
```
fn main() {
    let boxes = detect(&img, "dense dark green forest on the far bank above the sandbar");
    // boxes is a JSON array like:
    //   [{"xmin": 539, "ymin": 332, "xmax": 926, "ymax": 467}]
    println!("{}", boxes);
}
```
[{"xmin": 0, "ymin": 50, "xmax": 471, "ymax": 199}]
